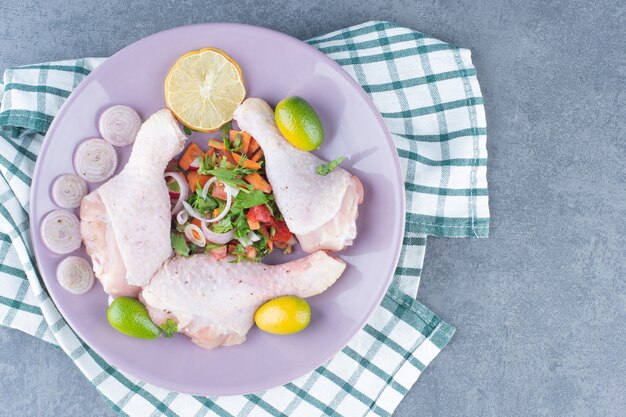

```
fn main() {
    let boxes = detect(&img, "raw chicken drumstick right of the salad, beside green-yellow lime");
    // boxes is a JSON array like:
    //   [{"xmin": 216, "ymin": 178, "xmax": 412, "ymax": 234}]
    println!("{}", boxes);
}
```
[{"xmin": 234, "ymin": 98, "xmax": 363, "ymax": 253}]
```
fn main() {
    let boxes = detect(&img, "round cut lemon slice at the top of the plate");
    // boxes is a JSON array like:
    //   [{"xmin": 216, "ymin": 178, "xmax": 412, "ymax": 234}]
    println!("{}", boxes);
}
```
[{"xmin": 165, "ymin": 48, "xmax": 246, "ymax": 132}]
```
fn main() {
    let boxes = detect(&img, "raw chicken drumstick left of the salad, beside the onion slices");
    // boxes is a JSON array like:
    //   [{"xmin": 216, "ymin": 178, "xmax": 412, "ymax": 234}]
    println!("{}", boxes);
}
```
[{"xmin": 80, "ymin": 109, "xmax": 186, "ymax": 297}]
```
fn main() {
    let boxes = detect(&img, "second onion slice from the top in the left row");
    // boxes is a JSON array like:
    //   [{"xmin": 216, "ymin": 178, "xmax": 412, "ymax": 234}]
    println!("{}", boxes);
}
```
[{"xmin": 74, "ymin": 138, "xmax": 117, "ymax": 182}]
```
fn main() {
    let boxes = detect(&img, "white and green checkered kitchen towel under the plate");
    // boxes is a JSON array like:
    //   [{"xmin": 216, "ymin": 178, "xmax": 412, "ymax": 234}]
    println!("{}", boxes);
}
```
[{"xmin": 0, "ymin": 22, "xmax": 489, "ymax": 417}]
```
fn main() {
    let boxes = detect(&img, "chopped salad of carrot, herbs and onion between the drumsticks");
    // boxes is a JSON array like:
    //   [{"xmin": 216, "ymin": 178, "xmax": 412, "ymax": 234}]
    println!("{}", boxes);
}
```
[{"xmin": 165, "ymin": 123, "xmax": 296, "ymax": 262}]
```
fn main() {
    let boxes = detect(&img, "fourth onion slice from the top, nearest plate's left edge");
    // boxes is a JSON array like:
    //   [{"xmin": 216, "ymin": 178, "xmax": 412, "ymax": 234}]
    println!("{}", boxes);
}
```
[{"xmin": 40, "ymin": 210, "xmax": 81, "ymax": 255}]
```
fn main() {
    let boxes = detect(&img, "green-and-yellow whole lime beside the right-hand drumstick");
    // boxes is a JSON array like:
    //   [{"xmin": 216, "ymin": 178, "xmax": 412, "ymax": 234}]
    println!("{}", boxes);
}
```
[{"xmin": 275, "ymin": 96, "xmax": 324, "ymax": 151}]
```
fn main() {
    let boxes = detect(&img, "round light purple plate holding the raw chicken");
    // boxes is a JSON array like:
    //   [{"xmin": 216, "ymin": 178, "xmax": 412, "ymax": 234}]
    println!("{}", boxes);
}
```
[{"xmin": 30, "ymin": 24, "xmax": 404, "ymax": 396}]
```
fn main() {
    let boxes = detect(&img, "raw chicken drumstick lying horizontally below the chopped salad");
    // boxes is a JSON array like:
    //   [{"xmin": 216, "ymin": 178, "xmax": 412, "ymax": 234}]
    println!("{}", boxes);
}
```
[{"xmin": 139, "ymin": 251, "xmax": 346, "ymax": 349}]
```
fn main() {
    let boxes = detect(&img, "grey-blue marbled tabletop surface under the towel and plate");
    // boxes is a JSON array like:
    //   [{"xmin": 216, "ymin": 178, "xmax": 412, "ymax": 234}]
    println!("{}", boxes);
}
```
[{"xmin": 0, "ymin": 0, "xmax": 626, "ymax": 417}]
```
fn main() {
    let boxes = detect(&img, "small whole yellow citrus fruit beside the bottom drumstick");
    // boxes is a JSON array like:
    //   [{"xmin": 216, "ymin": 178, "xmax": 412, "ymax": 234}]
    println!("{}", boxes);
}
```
[{"xmin": 254, "ymin": 295, "xmax": 311, "ymax": 334}]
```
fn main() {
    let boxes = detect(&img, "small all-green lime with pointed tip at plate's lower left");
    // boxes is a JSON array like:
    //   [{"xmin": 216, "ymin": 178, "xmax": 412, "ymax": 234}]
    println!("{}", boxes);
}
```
[{"xmin": 107, "ymin": 297, "xmax": 161, "ymax": 339}]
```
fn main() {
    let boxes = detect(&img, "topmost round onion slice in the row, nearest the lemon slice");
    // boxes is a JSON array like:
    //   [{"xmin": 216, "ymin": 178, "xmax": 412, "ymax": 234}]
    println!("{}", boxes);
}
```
[{"xmin": 98, "ymin": 104, "xmax": 141, "ymax": 146}]
